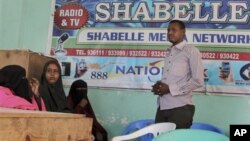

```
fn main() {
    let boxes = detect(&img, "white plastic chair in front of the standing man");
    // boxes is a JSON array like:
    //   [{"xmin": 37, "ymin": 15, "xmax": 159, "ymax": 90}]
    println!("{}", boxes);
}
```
[{"xmin": 112, "ymin": 122, "xmax": 176, "ymax": 141}]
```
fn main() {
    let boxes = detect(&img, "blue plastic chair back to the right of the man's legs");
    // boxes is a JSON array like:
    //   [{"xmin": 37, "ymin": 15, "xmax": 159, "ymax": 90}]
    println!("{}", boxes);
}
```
[{"xmin": 190, "ymin": 122, "xmax": 225, "ymax": 135}]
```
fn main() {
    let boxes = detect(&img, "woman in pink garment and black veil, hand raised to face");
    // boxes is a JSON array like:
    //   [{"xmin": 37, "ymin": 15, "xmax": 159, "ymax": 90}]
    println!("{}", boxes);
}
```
[{"xmin": 0, "ymin": 65, "xmax": 46, "ymax": 111}]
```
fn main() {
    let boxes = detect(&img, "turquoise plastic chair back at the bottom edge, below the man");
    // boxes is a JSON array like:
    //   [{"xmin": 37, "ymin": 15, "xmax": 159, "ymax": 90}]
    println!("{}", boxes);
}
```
[{"xmin": 153, "ymin": 129, "xmax": 229, "ymax": 141}]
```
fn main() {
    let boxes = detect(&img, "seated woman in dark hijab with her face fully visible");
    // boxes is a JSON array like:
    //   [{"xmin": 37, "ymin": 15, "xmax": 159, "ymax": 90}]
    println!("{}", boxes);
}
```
[{"xmin": 40, "ymin": 60, "xmax": 72, "ymax": 113}]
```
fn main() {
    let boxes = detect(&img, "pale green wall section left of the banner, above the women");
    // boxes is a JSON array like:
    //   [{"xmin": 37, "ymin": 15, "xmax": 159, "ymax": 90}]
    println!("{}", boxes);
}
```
[{"xmin": 0, "ymin": 0, "xmax": 54, "ymax": 53}]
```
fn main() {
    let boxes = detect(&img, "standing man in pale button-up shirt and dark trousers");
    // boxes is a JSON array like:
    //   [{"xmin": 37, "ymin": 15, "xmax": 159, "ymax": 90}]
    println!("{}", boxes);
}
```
[{"xmin": 152, "ymin": 20, "xmax": 204, "ymax": 128}]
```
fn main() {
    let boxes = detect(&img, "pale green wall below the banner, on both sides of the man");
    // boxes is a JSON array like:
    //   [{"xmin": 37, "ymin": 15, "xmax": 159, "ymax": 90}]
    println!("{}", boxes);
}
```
[{"xmin": 77, "ymin": 89, "xmax": 250, "ymax": 137}]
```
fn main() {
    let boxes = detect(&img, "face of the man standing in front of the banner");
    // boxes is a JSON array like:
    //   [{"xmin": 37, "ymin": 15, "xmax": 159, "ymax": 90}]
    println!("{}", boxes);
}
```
[{"xmin": 168, "ymin": 23, "xmax": 185, "ymax": 45}]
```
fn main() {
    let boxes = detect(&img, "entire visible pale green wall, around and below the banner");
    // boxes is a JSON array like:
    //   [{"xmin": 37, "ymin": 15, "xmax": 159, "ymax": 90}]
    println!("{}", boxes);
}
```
[{"xmin": 0, "ymin": 0, "xmax": 250, "ymax": 138}]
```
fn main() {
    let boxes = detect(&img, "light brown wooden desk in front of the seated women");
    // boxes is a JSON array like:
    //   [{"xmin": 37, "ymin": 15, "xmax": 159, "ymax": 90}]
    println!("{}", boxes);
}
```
[{"xmin": 0, "ymin": 108, "xmax": 93, "ymax": 141}]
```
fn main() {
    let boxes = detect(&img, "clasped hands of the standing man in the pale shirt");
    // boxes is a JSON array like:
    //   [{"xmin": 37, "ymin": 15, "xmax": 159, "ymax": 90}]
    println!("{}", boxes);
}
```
[{"xmin": 152, "ymin": 81, "xmax": 170, "ymax": 96}]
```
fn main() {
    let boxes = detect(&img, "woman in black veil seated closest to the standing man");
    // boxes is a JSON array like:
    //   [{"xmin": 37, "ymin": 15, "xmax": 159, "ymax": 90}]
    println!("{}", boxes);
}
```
[{"xmin": 67, "ymin": 80, "xmax": 108, "ymax": 141}]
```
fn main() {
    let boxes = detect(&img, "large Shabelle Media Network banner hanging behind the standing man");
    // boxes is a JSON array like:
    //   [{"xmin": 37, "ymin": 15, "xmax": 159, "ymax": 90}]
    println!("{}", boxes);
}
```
[{"xmin": 51, "ymin": 0, "xmax": 250, "ymax": 94}]
